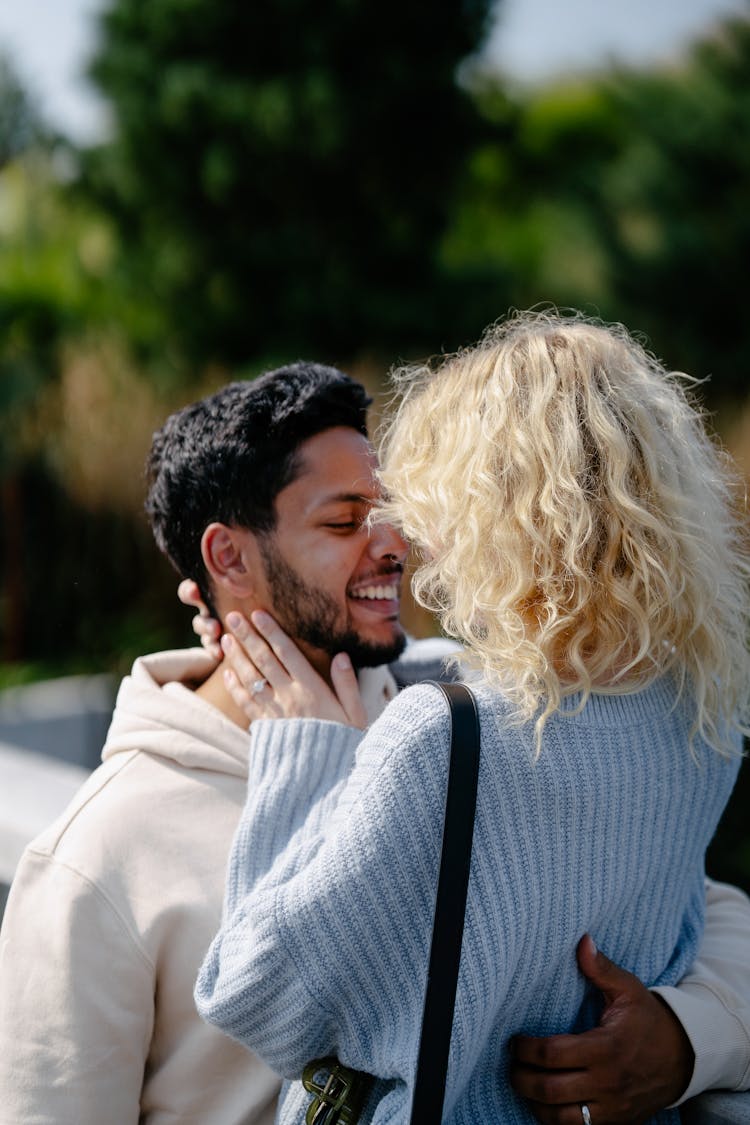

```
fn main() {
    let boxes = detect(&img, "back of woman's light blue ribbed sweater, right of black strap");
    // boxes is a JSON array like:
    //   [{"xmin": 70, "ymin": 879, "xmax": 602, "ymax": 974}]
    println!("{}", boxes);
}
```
[{"xmin": 445, "ymin": 682, "xmax": 739, "ymax": 1122}]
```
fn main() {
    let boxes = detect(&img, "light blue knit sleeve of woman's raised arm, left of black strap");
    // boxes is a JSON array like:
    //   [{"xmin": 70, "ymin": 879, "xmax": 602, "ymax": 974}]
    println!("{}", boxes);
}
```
[{"xmin": 196, "ymin": 685, "xmax": 450, "ymax": 1079}]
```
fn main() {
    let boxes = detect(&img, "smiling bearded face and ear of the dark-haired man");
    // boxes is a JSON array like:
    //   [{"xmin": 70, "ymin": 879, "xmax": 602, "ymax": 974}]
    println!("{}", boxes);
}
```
[{"xmin": 205, "ymin": 425, "xmax": 406, "ymax": 676}]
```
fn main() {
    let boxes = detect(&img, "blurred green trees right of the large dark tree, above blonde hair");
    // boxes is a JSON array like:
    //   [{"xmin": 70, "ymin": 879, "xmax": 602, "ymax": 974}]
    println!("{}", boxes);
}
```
[{"xmin": 452, "ymin": 9, "xmax": 750, "ymax": 402}]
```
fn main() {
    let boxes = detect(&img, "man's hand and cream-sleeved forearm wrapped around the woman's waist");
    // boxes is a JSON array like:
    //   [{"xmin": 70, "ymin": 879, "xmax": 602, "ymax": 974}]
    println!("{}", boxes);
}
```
[{"xmin": 512, "ymin": 881, "xmax": 750, "ymax": 1125}]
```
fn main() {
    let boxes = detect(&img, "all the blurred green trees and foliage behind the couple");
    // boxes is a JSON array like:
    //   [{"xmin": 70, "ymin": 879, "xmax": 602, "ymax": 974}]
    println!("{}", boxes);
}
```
[{"xmin": 0, "ymin": 0, "xmax": 750, "ymax": 889}]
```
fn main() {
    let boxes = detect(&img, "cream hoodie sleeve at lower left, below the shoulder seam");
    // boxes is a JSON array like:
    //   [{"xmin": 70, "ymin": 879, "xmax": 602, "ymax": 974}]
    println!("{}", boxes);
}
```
[{"xmin": 0, "ymin": 848, "xmax": 154, "ymax": 1125}]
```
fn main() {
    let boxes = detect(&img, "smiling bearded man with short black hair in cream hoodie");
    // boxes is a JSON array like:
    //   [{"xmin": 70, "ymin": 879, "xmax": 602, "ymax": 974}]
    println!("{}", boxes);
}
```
[{"xmin": 0, "ymin": 363, "xmax": 458, "ymax": 1125}]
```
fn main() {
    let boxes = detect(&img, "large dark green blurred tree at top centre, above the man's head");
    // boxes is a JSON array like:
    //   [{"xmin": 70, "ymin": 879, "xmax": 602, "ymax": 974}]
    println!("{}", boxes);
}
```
[{"xmin": 87, "ymin": 0, "xmax": 490, "ymax": 363}]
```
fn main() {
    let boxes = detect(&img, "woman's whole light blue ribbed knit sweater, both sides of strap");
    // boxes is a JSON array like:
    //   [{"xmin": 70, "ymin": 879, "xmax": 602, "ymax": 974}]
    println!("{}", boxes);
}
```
[{"xmin": 196, "ymin": 682, "xmax": 738, "ymax": 1125}]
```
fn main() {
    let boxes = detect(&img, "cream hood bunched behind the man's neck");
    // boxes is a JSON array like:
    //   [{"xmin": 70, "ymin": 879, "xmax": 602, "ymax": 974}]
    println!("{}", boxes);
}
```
[{"xmin": 101, "ymin": 648, "xmax": 250, "ymax": 776}]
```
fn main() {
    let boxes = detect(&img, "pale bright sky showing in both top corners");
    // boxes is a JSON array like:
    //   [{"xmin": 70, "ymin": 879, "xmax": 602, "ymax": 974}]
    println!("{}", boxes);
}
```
[{"xmin": 0, "ymin": 0, "xmax": 750, "ymax": 141}]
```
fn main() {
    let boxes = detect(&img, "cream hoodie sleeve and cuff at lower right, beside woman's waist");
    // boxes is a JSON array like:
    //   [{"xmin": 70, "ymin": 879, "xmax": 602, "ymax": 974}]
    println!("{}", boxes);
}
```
[{"xmin": 653, "ymin": 880, "xmax": 750, "ymax": 1105}]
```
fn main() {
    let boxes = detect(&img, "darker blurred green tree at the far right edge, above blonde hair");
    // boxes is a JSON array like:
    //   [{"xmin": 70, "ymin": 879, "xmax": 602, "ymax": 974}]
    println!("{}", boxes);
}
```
[{"xmin": 591, "ymin": 16, "xmax": 750, "ymax": 398}]
